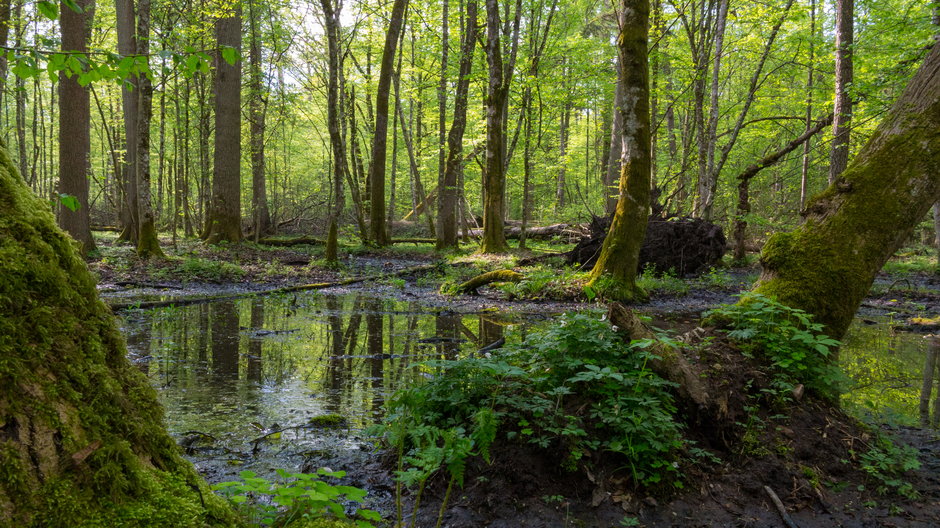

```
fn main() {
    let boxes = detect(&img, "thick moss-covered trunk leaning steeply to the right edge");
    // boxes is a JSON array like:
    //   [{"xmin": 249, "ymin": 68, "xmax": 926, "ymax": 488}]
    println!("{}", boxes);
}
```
[{"xmin": 756, "ymin": 46, "xmax": 940, "ymax": 338}]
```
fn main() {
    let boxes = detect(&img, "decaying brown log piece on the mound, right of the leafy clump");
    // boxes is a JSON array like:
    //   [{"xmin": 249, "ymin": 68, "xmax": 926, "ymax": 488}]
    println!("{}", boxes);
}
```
[{"xmin": 607, "ymin": 303, "xmax": 709, "ymax": 408}]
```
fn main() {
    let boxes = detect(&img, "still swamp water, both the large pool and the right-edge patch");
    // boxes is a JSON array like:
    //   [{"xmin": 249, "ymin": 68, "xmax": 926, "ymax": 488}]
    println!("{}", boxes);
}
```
[{"xmin": 122, "ymin": 292, "xmax": 940, "ymax": 482}]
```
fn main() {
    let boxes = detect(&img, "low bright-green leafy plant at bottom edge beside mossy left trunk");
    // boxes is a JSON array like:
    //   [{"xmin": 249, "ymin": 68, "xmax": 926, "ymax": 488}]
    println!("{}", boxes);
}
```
[{"xmin": 212, "ymin": 468, "xmax": 382, "ymax": 528}]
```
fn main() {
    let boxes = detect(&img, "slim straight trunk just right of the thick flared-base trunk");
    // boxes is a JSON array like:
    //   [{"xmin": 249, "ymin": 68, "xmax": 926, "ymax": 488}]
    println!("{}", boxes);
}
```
[{"xmin": 248, "ymin": 0, "xmax": 272, "ymax": 241}]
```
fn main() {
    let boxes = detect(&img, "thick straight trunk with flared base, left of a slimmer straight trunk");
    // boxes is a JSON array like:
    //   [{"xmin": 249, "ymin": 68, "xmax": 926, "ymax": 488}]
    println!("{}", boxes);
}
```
[{"xmin": 203, "ymin": 3, "xmax": 242, "ymax": 244}]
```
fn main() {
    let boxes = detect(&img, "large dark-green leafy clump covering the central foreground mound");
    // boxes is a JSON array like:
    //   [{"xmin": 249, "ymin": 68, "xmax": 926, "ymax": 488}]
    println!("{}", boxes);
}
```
[{"xmin": 373, "ymin": 314, "xmax": 684, "ymax": 512}]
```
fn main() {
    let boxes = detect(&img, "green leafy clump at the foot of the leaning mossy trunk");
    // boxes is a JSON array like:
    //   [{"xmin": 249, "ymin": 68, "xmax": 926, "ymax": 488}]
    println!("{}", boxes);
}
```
[{"xmin": 705, "ymin": 293, "xmax": 848, "ymax": 401}]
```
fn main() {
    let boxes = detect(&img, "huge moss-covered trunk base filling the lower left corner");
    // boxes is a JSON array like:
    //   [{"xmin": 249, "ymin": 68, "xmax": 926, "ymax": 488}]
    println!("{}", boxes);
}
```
[{"xmin": 0, "ymin": 146, "xmax": 233, "ymax": 527}]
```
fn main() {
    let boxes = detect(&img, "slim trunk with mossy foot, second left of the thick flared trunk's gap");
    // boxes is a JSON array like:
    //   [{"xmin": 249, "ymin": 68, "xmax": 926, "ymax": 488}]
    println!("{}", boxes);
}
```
[{"xmin": 137, "ymin": 0, "xmax": 163, "ymax": 258}]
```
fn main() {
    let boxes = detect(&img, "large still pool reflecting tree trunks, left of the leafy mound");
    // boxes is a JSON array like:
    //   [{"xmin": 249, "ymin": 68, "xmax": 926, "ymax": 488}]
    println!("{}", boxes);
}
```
[{"xmin": 123, "ymin": 293, "xmax": 520, "ymax": 478}]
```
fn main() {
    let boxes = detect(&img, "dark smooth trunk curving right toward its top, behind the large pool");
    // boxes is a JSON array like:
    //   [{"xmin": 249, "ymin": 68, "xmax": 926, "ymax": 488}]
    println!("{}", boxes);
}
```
[{"xmin": 369, "ymin": 0, "xmax": 408, "ymax": 246}]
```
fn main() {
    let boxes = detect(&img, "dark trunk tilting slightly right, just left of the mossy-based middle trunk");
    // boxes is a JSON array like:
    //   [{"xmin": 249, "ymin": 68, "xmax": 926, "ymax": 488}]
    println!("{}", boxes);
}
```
[{"xmin": 437, "ymin": 0, "xmax": 479, "ymax": 249}]
